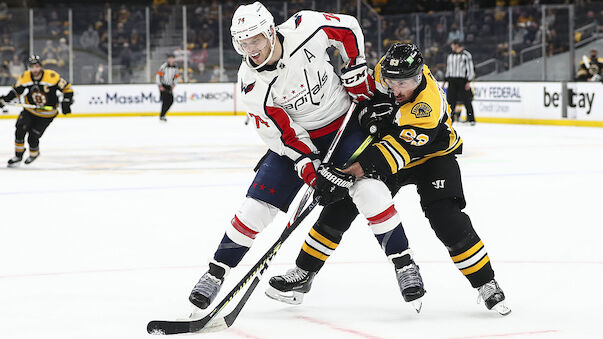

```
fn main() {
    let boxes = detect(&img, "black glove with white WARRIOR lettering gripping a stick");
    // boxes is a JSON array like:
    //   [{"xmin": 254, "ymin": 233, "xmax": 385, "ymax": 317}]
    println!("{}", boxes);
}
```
[{"xmin": 314, "ymin": 163, "xmax": 356, "ymax": 206}]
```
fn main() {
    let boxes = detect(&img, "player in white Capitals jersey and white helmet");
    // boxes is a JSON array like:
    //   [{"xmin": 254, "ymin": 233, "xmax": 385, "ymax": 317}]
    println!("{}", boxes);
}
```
[{"xmin": 189, "ymin": 2, "xmax": 424, "ymax": 309}]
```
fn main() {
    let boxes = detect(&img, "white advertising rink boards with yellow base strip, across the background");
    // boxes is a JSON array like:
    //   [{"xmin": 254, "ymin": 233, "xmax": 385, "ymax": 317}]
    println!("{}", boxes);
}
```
[{"xmin": 0, "ymin": 81, "xmax": 603, "ymax": 126}]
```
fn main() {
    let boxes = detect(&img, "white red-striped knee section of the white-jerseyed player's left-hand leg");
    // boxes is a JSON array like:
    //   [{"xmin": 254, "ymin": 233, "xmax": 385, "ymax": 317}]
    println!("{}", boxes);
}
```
[{"xmin": 226, "ymin": 197, "xmax": 278, "ymax": 247}]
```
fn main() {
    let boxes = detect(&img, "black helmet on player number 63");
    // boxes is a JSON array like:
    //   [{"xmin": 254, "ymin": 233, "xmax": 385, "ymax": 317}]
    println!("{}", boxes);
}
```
[{"xmin": 381, "ymin": 43, "xmax": 424, "ymax": 79}]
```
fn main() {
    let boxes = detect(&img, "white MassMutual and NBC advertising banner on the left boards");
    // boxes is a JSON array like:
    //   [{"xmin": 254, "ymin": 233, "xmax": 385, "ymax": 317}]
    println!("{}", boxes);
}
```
[{"xmin": 0, "ymin": 83, "xmax": 243, "ymax": 117}]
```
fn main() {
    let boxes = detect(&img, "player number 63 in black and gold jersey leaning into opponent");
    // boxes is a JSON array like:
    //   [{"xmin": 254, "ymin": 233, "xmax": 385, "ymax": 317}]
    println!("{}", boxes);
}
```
[{"xmin": 266, "ymin": 44, "xmax": 511, "ymax": 315}]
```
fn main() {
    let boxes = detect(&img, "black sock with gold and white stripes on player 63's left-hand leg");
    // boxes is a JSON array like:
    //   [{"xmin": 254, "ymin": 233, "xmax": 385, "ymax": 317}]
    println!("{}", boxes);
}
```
[{"xmin": 295, "ymin": 224, "xmax": 342, "ymax": 272}]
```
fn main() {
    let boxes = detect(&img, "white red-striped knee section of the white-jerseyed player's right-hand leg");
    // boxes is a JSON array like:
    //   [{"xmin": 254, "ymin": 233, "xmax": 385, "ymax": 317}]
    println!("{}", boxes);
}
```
[{"xmin": 350, "ymin": 179, "xmax": 400, "ymax": 234}]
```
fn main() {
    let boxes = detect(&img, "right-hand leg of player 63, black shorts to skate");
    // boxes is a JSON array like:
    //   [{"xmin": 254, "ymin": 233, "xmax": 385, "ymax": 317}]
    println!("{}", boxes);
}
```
[{"xmin": 415, "ymin": 155, "xmax": 510, "ymax": 314}]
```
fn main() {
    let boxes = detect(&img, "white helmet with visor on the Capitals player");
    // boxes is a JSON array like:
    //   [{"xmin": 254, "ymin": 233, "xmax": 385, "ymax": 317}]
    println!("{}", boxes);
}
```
[{"xmin": 230, "ymin": 1, "xmax": 276, "ymax": 69}]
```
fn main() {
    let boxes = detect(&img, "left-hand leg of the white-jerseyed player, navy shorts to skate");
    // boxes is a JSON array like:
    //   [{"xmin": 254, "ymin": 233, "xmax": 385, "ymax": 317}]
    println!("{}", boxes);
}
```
[{"xmin": 189, "ymin": 151, "xmax": 303, "ymax": 309}]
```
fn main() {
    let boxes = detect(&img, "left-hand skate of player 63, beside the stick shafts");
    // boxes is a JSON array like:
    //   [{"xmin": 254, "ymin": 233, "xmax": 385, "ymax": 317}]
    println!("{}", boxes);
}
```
[{"xmin": 266, "ymin": 267, "xmax": 316, "ymax": 305}]
